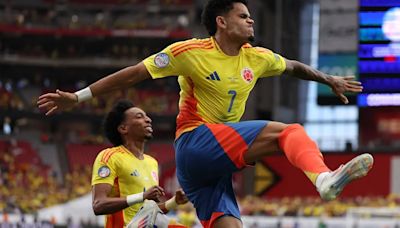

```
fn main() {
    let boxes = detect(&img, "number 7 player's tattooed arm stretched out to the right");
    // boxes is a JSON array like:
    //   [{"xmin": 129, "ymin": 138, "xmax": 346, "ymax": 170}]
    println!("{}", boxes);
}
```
[{"xmin": 285, "ymin": 59, "xmax": 363, "ymax": 104}]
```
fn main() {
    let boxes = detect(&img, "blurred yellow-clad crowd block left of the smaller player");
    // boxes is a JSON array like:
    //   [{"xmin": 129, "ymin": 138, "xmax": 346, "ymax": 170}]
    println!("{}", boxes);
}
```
[{"xmin": 0, "ymin": 142, "xmax": 91, "ymax": 214}]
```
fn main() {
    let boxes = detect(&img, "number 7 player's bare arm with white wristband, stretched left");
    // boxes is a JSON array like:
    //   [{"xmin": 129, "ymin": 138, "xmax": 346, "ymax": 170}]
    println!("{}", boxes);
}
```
[{"xmin": 37, "ymin": 62, "xmax": 151, "ymax": 115}]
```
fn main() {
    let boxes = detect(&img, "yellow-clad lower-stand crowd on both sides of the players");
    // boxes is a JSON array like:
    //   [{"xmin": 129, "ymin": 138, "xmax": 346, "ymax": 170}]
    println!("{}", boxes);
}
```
[{"xmin": 0, "ymin": 138, "xmax": 400, "ymax": 218}]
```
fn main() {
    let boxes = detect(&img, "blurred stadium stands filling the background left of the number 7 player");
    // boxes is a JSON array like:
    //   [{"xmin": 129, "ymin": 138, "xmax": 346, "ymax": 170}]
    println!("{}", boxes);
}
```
[{"xmin": 0, "ymin": 0, "xmax": 188, "ymax": 225}]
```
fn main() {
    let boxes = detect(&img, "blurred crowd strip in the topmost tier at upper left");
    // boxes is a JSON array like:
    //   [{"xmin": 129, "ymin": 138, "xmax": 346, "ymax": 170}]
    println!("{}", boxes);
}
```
[{"xmin": 0, "ymin": 0, "xmax": 193, "ymax": 31}]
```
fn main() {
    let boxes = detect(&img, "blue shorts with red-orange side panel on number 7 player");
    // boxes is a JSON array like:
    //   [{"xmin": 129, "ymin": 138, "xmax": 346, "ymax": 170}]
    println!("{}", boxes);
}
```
[{"xmin": 175, "ymin": 120, "xmax": 268, "ymax": 227}]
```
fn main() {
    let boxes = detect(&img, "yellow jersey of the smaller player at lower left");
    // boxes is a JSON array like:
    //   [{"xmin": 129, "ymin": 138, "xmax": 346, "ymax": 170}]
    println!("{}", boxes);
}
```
[{"xmin": 92, "ymin": 146, "xmax": 159, "ymax": 228}]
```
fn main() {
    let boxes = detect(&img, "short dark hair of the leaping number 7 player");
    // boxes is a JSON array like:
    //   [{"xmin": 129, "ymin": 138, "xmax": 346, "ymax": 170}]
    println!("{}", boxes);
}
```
[{"xmin": 201, "ymin": 0, "xmax": 247, "ymax": 36}]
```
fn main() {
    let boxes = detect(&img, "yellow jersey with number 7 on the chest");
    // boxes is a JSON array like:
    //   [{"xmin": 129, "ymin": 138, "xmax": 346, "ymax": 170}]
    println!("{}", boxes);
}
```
[{"xmin": 143, "ymin": 37, "xmax": 286, "ymax": 138}]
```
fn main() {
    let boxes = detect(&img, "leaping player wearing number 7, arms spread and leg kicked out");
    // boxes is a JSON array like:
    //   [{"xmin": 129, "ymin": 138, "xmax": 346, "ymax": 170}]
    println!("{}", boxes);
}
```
[{"xmin": 38, "ymin": 0, "xmax": 373, "ymax": 228}]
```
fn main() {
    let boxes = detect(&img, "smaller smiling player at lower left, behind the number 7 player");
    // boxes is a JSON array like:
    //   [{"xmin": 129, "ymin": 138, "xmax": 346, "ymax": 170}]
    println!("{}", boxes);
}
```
[{"xmin": 92, "ymin": 101, "xmax": 188, "ymax": 228}]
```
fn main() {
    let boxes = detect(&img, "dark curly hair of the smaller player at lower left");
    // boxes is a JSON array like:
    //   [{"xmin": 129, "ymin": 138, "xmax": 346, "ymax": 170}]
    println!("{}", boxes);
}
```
[{"xmin": 103, "ymin": 100, "xmax": 135, "ymax": 146}]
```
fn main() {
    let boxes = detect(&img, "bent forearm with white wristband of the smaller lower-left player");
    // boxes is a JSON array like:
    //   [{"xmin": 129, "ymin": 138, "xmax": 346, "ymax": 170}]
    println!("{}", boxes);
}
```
[{"xmin": 92, "ymin": 184, "xmax": 164, "ymax": 215}]
